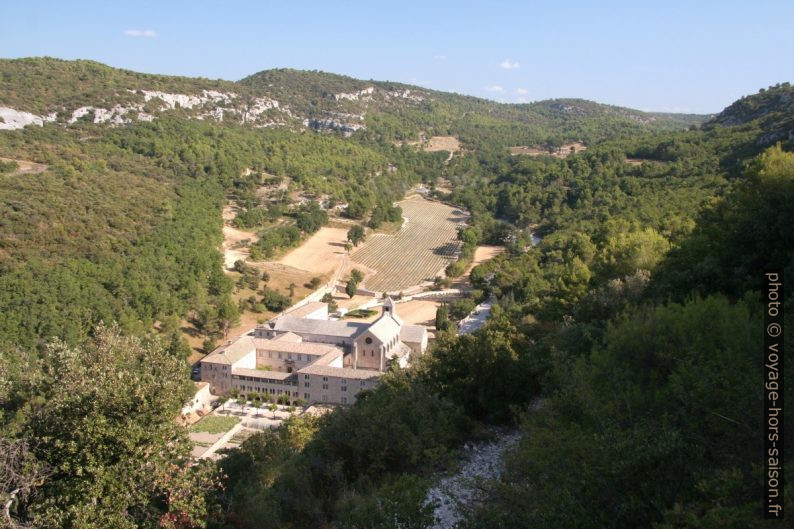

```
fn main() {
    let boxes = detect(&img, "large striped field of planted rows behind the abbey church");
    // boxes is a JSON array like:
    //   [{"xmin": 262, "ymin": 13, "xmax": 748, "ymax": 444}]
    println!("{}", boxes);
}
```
[{"xmin": 352, "ymin": 197, "xmax": 468, "ymax": 292}]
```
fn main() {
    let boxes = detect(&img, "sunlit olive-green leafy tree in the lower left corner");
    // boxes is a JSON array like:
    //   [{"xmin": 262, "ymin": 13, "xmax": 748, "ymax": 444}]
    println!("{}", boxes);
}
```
[{"xmin": 0, "ymin": 327, "xmax": 217, "ymax": 528}]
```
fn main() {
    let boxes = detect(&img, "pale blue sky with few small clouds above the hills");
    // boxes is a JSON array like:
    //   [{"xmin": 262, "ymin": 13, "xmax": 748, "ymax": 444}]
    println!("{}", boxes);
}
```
[{"xmin": 0, "ymin": 0, "xmax": 794, "ymax": 113}]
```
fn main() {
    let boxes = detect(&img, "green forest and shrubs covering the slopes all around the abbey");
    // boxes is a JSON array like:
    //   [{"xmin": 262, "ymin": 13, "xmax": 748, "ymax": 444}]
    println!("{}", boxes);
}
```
[{"xmin": 0, "ymin": 59, "xmax": 794, "ymax": 529}]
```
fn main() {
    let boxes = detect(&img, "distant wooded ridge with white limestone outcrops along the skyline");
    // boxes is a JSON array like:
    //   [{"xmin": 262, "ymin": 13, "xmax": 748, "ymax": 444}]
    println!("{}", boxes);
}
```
[{"xmin": 0, "ymin": 58, "xmax": 707, "ymax": 147}]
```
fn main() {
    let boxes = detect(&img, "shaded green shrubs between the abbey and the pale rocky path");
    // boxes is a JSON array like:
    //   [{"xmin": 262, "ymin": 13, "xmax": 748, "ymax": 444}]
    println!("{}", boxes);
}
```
[{"xmin": 215, "ymin": 373, "xmax": 471, "ymax": 527}]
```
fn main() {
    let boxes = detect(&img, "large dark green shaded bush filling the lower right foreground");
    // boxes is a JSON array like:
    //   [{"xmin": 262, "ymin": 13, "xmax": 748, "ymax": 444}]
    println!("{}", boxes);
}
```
[{"xmin": 470, "ymin": 297, "xmax": 762, "ymax": 528}]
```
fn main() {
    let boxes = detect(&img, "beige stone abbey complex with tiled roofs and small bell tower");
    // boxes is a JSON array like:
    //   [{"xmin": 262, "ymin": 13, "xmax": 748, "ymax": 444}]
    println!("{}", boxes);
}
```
[{"xmin": 201, "ymin": 299, "xmax": 427, "ymax": 404}]
